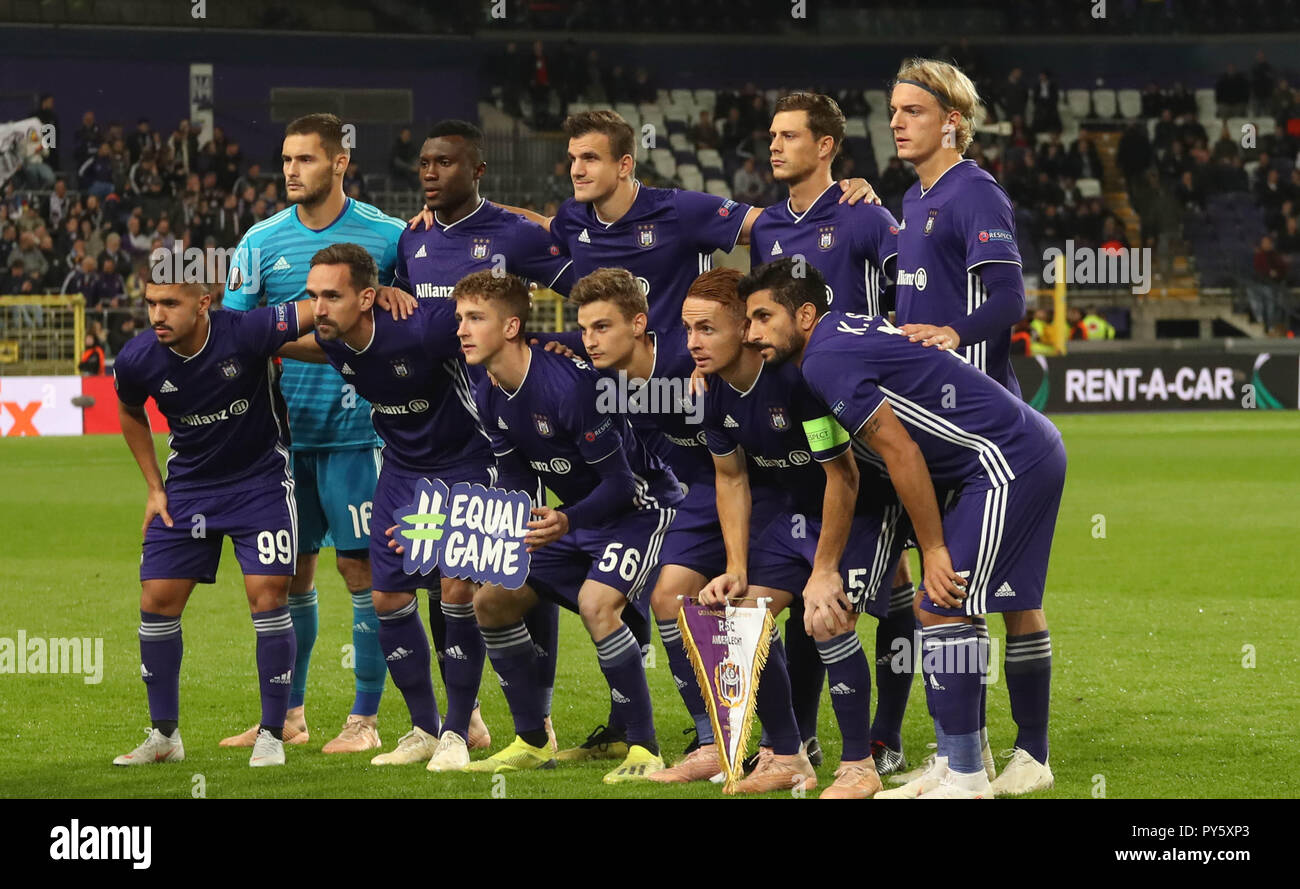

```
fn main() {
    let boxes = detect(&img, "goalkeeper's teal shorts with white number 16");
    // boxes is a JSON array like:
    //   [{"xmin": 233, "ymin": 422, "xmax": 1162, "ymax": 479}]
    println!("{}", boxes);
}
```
[{"xmin": 293, "ymin": 447, "xmax": 380, "ymax": 555}]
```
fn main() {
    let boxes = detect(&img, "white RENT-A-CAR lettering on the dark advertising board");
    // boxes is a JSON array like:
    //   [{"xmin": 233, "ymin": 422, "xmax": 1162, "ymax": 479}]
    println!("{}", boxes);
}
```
[{"xmin": 1065, "ymin": 367, "xmax": 1236, "ymax": 404}]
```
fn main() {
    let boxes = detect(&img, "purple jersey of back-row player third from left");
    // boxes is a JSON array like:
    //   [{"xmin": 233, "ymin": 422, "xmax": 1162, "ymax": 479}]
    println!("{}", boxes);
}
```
[{"xmin": 551, "ymin": 182, "xmax": 750, "ymax": 333}]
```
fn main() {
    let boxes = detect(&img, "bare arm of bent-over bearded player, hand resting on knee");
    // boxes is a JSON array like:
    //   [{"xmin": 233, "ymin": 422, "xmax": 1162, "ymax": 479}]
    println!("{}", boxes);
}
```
[{"xmin": 857, "ymin": 402, "xmax": 966, "ymax": 608}]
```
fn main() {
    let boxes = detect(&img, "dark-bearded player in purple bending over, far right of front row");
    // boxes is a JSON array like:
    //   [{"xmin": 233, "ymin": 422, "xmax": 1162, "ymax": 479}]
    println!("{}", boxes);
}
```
[{"xmin": 748, "ymin": 254, "xmax": 1066, "ymax": 799}]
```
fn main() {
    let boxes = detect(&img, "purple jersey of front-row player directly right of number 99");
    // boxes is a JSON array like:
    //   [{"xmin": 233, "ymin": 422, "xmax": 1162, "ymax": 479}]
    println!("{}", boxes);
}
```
[{"xmin": 316, "ymin": 300, "xmax": 491, "ymax": 474}]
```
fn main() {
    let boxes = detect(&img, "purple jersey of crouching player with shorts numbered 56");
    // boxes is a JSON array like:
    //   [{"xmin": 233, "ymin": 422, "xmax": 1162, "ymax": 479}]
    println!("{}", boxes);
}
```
[{"xmin": 475, "ymin": 346, "xmax": 681, "ymax": 512}]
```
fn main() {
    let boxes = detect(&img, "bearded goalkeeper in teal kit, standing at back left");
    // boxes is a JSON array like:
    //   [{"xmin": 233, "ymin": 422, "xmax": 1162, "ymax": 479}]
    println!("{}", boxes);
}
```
[{"xmin": 221, "ymin": 114, "xmax": 406, "ymax": 753}]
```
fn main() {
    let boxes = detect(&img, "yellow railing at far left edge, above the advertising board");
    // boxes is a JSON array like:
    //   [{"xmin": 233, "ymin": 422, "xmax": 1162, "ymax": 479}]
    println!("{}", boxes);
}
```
[{"xmin": 0, "ymin": 294, "xmax": 86, "ymax": 377}]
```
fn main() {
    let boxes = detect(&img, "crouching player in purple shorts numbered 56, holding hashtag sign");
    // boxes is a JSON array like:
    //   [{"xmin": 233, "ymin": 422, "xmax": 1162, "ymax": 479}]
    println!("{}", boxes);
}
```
[{"xmin": 454, "ymin": 272, "xmax": 681, "ymax": 784}]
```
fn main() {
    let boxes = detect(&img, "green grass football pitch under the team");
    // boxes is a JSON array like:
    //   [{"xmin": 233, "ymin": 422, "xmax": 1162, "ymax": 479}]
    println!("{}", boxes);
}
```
[{"xmin": 0, "ymin": 411, "xmax": 1300, "ymax": 798}]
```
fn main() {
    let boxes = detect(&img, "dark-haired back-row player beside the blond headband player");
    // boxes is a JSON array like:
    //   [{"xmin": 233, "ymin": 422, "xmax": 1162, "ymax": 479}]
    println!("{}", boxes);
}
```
[{"xmin": 749, "ymin": 92, "xmax": 915, "ymax": 775}]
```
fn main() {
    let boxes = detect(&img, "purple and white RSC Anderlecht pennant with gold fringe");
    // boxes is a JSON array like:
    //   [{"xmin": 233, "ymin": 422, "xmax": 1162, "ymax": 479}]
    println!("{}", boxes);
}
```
[{"xmin": 677, "ymin": 599, "xmax": 776, "ymax": 789}]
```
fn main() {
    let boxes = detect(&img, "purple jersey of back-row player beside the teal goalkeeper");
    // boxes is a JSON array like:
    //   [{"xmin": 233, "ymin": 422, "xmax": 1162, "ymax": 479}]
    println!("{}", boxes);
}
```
[{"xmin": 395, "ymin": 200, "xmax": 575, "ymax": 299}]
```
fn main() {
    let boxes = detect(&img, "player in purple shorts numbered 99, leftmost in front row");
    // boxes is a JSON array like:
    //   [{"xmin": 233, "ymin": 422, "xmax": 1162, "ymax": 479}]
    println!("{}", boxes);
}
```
[{"xmin": 113, "ymin": 283, "xmax": 322, "ymax": 767}]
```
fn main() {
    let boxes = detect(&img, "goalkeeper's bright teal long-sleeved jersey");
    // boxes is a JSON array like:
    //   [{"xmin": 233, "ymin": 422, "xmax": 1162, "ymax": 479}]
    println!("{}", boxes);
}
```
[{"xmin": 224, "ymin": 198, "xmax": 406, "ymax": 451}]
